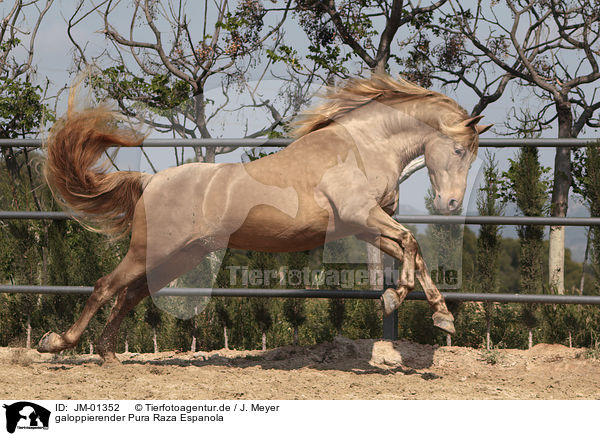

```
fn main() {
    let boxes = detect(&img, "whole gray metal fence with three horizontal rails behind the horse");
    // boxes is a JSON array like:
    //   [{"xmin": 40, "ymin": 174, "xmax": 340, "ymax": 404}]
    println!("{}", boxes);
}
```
[{"xmin": 0, "ymin": 138, "xmax": 600, "ymax": 339}]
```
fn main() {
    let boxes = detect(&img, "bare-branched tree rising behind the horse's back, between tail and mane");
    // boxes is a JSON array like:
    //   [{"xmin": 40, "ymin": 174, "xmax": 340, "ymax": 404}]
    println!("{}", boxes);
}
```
[{"xmin": 68, "ymin": 0, "xmax": 314, "ymax": 162}]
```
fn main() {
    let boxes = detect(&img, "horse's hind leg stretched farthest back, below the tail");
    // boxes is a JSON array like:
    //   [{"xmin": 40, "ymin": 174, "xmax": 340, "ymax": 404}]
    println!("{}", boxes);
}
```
[{"xmin": 38, "ymin": 251, "xmax": 146, "ymax": 353}]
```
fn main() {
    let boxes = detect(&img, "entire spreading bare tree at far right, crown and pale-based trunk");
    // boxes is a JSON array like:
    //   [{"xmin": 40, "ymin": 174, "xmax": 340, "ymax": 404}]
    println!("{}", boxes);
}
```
[{"xmin": 423, "ymin": 0, "xmax": 600, "ymax": 294}]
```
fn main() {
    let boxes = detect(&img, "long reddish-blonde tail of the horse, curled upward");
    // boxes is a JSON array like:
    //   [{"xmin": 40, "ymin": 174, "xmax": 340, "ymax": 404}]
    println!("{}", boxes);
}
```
[{"xmin": 44, "ymin": 101, "xmax": 148, "ymax": 238}]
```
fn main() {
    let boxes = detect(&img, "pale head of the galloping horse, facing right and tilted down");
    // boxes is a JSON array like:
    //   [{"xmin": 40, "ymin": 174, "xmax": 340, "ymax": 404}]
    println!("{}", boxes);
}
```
[{"xmin": 425, "ymin": 115, "xmax": 492, "ymax": 214}]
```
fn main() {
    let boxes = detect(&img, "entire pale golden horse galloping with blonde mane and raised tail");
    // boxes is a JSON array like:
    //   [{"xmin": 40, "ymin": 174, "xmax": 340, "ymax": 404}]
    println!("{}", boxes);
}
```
[{"xmin": 38, "ymin": 75, "xmax": 490, "ymax": 362}]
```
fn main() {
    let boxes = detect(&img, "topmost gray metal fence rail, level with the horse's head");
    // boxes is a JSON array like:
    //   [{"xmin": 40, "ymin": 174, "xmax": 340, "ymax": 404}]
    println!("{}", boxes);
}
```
[{"xmin": 0, "ymin": 138, "xmax": 598, "ymax": 148}]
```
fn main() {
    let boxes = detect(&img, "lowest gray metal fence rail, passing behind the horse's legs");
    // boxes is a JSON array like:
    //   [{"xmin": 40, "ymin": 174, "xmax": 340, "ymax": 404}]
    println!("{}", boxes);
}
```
[{"xmin": 0, "ymin": 285, "xmax": 600, "ymax": 305}]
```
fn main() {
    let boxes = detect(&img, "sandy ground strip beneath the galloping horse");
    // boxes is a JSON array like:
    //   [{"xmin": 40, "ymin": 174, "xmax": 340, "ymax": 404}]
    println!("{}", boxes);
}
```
[{"xmin": 0, "ymin": 338, "xmax": 600, "ymax": 400}]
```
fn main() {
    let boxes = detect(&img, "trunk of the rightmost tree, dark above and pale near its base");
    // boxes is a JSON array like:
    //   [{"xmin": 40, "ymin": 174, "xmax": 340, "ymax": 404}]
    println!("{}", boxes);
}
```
[{"xmin": 548, "ymin": 104, "xmax": 573, "ymax": 295}]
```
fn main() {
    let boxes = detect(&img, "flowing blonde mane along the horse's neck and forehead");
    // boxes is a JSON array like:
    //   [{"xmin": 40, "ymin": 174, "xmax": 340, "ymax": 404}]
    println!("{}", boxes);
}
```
[{"xmin": 292, "ymin": 74, "xmax": 477, "ymax": 148}]
